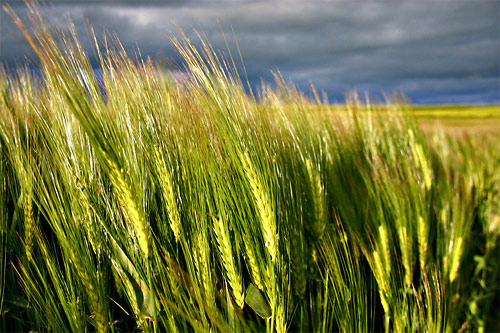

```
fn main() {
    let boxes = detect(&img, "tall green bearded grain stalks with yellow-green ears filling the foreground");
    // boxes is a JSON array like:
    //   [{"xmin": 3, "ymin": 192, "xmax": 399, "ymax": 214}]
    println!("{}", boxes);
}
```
[{"xmin": 0, "ymin": 7, "xmax": 500, "ymax": 332}]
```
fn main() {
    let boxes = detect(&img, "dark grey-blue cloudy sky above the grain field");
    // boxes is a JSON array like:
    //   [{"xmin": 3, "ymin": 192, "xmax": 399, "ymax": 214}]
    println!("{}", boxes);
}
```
[{"xmin": 0, "ymin": 0, "xmax": 500, "ymax": 104}]
